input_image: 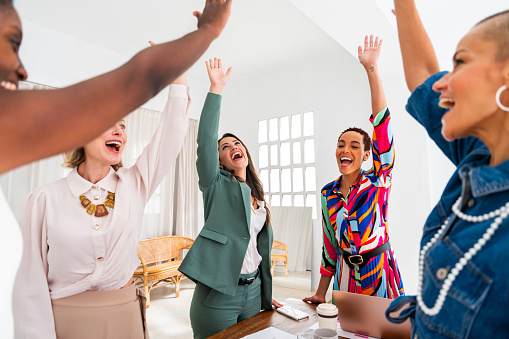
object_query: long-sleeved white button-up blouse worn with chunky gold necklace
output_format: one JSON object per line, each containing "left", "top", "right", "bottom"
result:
{"left": 13, "top": 85, "right": 190, "bottom": 338}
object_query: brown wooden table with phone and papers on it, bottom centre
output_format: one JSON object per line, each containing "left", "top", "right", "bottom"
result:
{"left": 210, "top": 300, "right": 343, "bottom": 339}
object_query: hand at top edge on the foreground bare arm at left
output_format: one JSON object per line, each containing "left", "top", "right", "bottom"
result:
{"left": 193, "top": 0, "right": 233, "bottom": 38}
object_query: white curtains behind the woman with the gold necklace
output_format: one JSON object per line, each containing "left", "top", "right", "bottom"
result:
{"left": 0, "top": 82, "right": 201, "bottom": 242}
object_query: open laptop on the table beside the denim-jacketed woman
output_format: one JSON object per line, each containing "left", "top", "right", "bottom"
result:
{"left": 332, "top": 291, "right": 411, "bottom": 339}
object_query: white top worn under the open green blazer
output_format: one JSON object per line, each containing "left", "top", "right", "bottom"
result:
{"left": 240, "top": 200, "right": 267, "bottom": 274}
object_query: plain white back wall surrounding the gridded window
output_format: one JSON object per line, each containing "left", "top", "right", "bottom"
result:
{"left": 216, "top": 46, "right": 430, "bottom": 292}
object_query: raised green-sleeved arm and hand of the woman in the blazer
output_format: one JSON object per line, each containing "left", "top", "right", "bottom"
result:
{"left": 196, "top": 58, "right": 232, "bottom": 190}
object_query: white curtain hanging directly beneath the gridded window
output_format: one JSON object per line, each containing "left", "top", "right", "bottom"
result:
{"left": 270, "top": 206, "right": 313, "bottom": 272}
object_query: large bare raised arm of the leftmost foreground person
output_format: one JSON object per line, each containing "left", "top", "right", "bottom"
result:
{"left": 0, "top": 0, "right": 232, "bottom": 173}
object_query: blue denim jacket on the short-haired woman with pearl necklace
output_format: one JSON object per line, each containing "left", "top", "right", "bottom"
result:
{"left": 387, "top": 73, "right": 509, "bottom": 339}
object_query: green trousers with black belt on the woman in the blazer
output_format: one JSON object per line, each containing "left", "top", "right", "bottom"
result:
{"left": 190, "top": 271, "right": 262, "bottom": 339}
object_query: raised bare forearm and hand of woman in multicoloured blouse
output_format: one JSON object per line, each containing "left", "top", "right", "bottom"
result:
{"left": 358, "top": 35, "right": 387, "bottom": 118}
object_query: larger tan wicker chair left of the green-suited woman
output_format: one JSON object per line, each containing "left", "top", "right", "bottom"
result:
{"left": 133, "top": 235, "right": 194, "bottom": 308}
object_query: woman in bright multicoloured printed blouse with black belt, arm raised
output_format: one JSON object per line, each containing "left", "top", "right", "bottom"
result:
{"left": 303, "top": 36, "right": 404, "bottom": 303}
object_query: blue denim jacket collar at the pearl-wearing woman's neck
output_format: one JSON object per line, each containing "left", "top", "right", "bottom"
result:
{"left": 458, "top": 146, "right": 509, "bottom": 198}
